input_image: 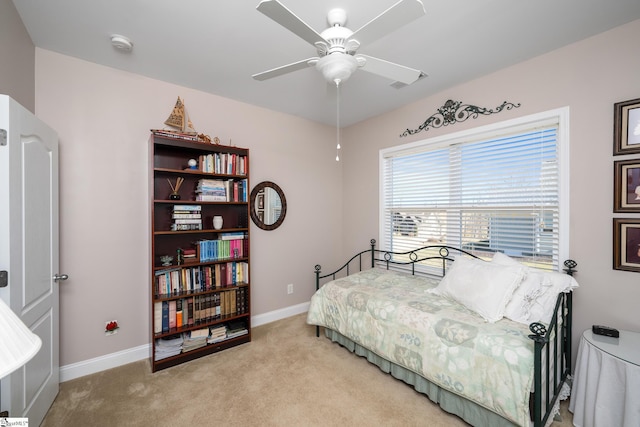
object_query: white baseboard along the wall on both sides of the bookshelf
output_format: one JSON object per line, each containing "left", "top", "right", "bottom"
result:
{"left": 60, "top": 302, "right": 309, "bottom": 383}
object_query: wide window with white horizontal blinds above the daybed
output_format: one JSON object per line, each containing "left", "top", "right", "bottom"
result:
{"left": 380, "top": 108, "right": 569, "bottom": 270}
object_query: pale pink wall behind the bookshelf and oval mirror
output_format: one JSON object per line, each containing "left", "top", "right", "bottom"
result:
{"left": 36, "top": 49, "right": 342, "bottom": 366}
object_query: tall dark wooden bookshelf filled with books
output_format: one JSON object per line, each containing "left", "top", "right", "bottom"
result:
{"left": 149, "top": 131, "right": 251, "bottom": 372}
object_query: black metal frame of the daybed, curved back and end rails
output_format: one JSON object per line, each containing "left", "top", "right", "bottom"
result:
{"left": 315, "top": 239, "right": 577, "bottom": 427}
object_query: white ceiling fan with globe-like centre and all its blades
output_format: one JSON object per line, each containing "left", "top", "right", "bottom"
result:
{"left": 252, "top": 0, "right": 426, "bottom": 86}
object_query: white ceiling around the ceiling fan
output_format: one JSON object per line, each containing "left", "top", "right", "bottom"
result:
{"left": 13, "top": 0, "right": 640, "bottom": 126}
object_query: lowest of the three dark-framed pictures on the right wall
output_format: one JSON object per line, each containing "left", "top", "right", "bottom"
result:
{"left": 613, "top": 218, "right": 640, "bottom": 272}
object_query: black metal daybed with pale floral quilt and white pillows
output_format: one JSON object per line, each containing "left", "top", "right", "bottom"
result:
{"left": 307, "top": 240, "right": 578, "bottom": 427}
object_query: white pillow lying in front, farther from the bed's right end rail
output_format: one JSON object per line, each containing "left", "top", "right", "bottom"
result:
{"left": 427, "top": 257, "right": 524, "bottom": 323}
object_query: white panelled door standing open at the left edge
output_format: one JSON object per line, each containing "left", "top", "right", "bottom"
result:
{"left": 0, "top": 95, "right": 60, "bottom": 426}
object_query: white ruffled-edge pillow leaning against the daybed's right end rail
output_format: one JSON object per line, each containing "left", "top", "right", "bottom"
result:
{"left": 491, "top": 252, "right": 578, "bottom": 325}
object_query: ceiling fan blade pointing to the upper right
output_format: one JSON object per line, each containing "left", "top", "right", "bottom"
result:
{"left": 349, "top": 0, "right": 425, "bottom": 45}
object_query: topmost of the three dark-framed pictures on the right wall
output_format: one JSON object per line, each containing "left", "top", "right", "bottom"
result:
{"left": 613, "top": 98, "right": 640, "bottom": 155}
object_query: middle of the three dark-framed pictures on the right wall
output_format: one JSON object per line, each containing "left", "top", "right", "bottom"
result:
{"left": 613, "top": 159, "right": 640, "bottom": 212}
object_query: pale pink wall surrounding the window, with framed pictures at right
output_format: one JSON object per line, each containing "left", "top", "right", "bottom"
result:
{"left": 342, "top": 21, "right": 640, "bottom": 362}
